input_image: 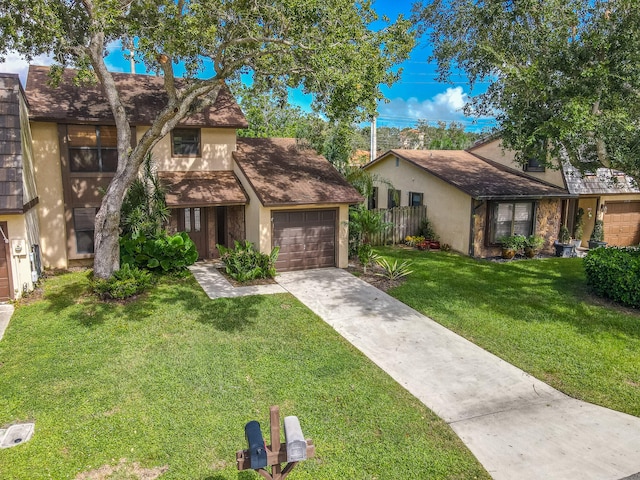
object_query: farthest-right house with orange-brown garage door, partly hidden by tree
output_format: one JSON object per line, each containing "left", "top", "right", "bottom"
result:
{"left": 469, "top": 139, "right": 640, "bottom": 246}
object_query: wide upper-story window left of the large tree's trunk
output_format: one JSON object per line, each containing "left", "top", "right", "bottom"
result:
{"left": 67, "top": 125, "right": 118, "bottom": 172}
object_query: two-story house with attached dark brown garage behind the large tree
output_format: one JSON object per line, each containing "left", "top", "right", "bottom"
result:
{"left": 26, "top": 66, "right": 362, "bottom": 280}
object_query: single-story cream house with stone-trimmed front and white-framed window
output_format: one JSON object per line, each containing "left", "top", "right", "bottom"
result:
{"left": 364, "top": 150, "right": 572, "bottom": 257}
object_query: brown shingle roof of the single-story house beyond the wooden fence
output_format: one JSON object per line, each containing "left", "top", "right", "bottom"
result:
{"left": 365, "top": 150, "right": 571, "bottom": 200}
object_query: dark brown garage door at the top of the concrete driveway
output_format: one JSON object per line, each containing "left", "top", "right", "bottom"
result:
{"left": 271, "top": 210, "right": 336, "bottom": 272}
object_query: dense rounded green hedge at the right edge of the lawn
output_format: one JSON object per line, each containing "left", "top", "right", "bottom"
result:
{"left": 584, "top": 247, "right": 640, "bottom": 308}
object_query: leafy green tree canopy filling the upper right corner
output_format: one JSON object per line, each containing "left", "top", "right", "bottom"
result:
{"left": 415, "top": 0, "right": 640, "bottom": 184}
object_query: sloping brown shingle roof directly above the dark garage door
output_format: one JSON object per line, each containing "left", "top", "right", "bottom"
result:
{"left": 233, "top": 138, "right": 363, "bottom": 206}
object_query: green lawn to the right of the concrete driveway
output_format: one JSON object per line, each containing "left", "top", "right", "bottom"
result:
{"left": 378, "top": 248, "right": 640, "bottom": 416}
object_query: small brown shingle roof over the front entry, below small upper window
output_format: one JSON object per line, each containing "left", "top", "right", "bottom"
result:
{"left": 158, "top": 171, "right": 248, "bottom": 208}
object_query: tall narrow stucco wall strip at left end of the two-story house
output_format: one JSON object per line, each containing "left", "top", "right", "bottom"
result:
{"left": 31, "top": 122, "right": 67, "bottom": 268}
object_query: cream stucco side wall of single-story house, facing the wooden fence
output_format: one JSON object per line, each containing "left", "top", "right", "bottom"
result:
{"left": 367, "top": 155, "right": 471, "bottom": 255}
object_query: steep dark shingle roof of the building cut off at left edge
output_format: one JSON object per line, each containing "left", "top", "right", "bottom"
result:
{"left": 0, "top": 73, "right": 24, "bottom": 212}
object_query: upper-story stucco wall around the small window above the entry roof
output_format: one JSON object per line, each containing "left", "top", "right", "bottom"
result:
{"left": 141, "top": 127, "right": 236, "bottom": 171}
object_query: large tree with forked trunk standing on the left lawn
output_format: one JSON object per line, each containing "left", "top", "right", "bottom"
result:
{"left": 0, "top": 0, "right": 413, "bottom": 278}
